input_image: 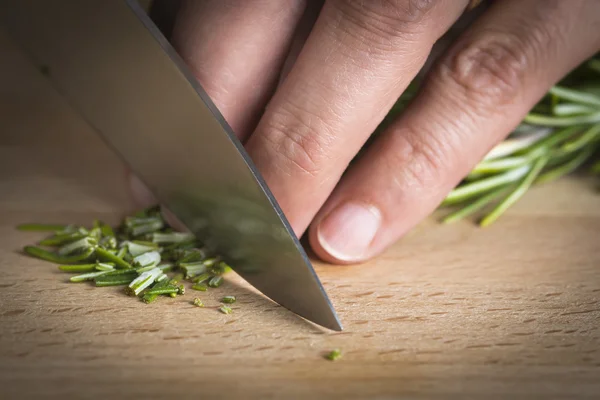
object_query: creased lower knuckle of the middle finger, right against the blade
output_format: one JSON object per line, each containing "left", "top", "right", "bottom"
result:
{"left": 262, "top": 103, "right": 332, "bottom": 177}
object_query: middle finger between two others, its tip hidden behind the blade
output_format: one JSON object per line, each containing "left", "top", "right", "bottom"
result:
{"left": 246, "top": 0, "right": 467, "bottom": 235}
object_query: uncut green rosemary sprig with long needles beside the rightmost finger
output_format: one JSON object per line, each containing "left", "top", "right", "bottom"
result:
{"left": 426, "top": 59, "right": 600, "bottom": 226}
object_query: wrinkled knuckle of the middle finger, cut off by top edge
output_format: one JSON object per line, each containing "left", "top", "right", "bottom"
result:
{"left": 332, "top": 0, "right": 439, "bottom": 43}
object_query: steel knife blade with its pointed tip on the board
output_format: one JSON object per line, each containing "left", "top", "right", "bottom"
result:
{"left": 0, "top": 0, "right": 342, "bottom": 331}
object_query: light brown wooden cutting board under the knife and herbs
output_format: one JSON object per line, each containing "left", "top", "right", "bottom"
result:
{"left": 0, "top": 28, "right": 600, "bottom": 399}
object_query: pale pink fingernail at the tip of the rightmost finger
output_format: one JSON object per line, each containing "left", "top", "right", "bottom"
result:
{"left": 317, "top": 203, "right": 381, "bottom": 262}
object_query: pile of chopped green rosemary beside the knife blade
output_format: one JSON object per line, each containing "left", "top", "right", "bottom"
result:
{"left": 18, "top": 206, "right": 235, "bottom": 305}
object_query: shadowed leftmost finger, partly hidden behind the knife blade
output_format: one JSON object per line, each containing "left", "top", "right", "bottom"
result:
{"left": 172, "top": 0, "right": 305, "bottom": 140}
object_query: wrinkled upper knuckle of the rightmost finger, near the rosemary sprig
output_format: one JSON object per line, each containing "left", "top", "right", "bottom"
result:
{"left": 437, "top": 33, "right": 530, "bottom": 107}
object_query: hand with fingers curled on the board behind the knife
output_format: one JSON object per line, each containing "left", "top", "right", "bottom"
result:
{"left": 130, "top": 0, "right": 600, "bottom": 263}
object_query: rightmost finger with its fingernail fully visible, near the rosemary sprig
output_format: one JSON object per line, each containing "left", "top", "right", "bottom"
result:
{"left": 309, "top": 0, "right": 600, "bottom": 263}
